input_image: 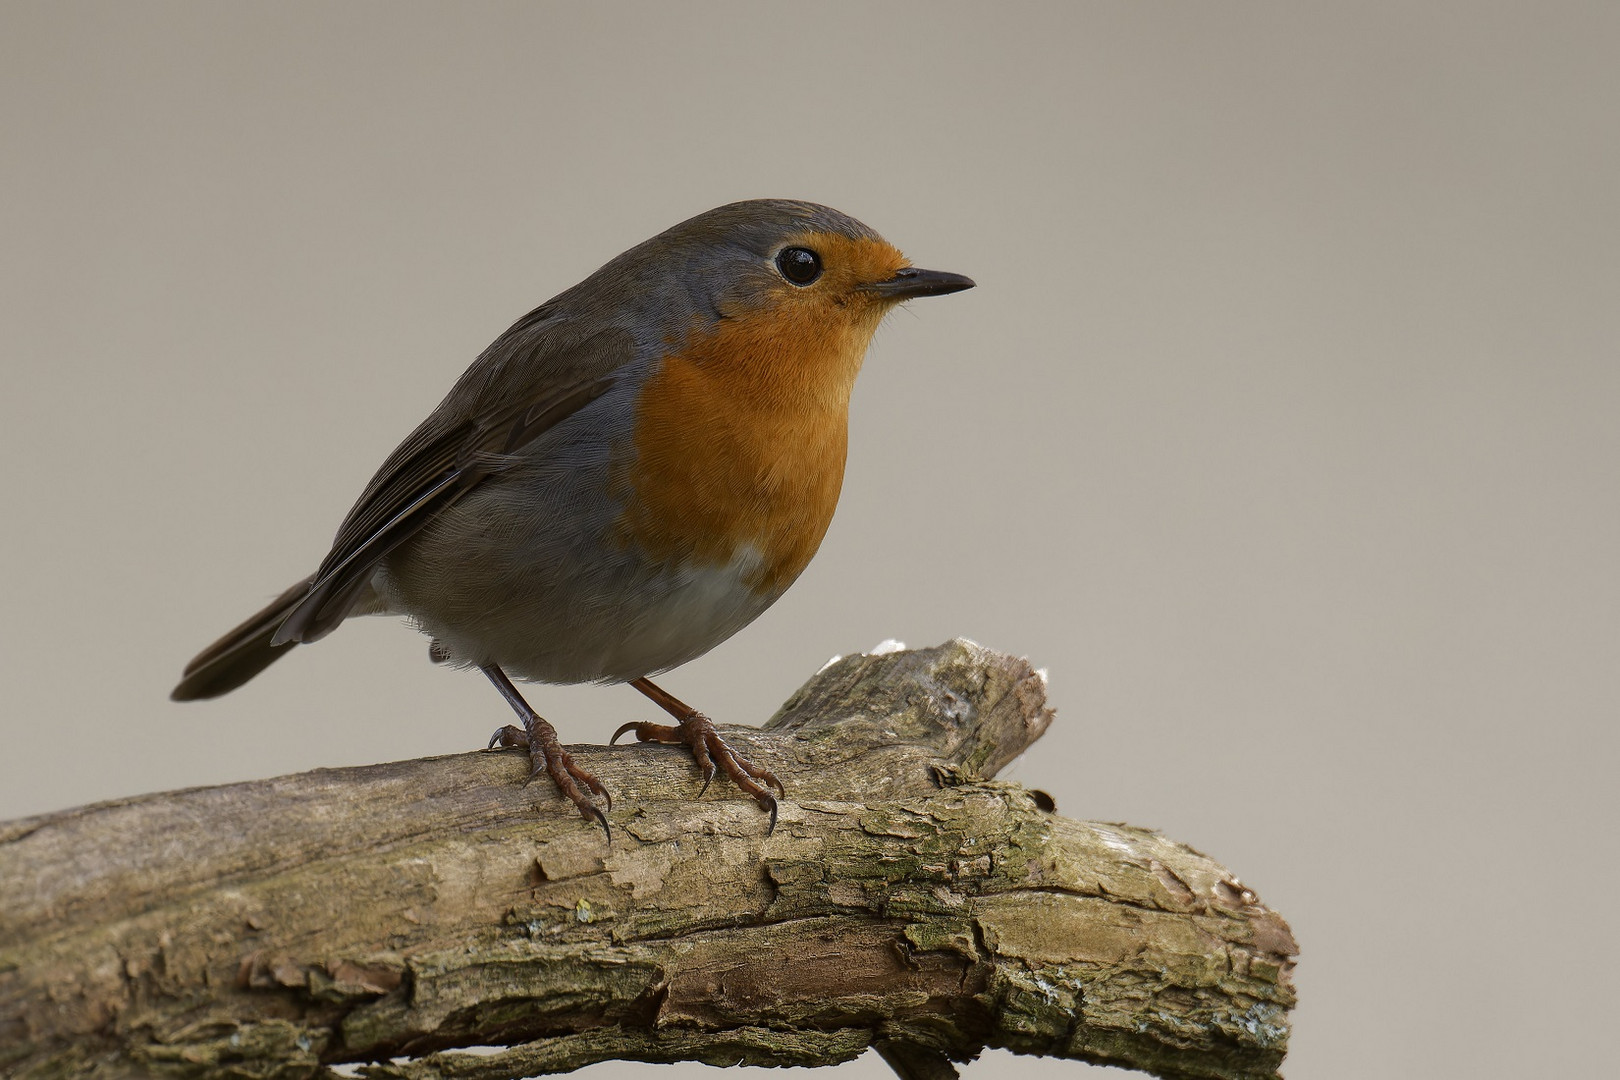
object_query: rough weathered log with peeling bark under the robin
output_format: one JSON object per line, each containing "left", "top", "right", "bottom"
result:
{"left": 0, "top": 641, "right": 1296, "bottom": 1080}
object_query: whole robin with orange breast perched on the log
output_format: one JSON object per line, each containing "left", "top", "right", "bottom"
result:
{"left": 172, "top": 199, "right": 974, "bottom": 840}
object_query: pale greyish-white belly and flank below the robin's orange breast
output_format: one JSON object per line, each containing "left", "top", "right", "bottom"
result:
{"left": 377, "top": 453, "right": 786, "bottom": 683}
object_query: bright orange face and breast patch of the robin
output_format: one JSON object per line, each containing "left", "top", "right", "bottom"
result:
{"left": 619, "top": 233, "right": 907, "bottom": 594}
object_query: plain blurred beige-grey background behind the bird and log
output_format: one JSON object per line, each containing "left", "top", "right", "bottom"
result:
{"left": 0, "top": 0, "right": 1620, "bottom": 1078}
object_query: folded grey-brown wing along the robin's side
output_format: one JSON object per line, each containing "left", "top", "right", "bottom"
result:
{"left": 271, "top": 317, "right": 632, "bottom": 646}
